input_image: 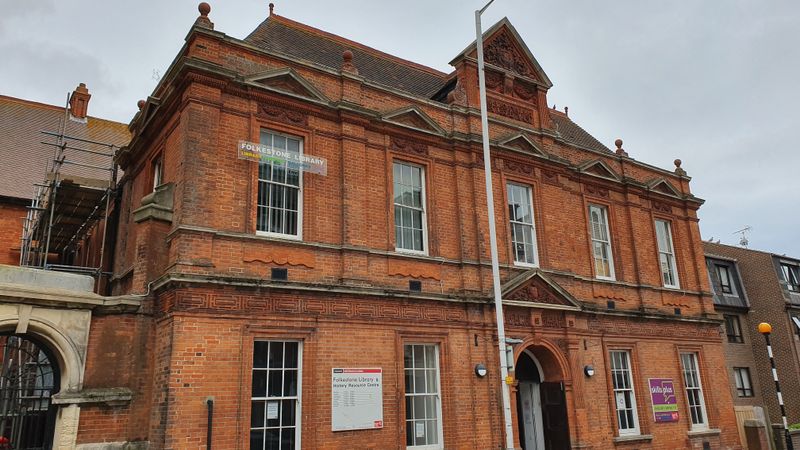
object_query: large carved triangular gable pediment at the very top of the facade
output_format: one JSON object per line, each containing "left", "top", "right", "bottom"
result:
{"left": 450, "top": 17, "right": 553, "bottom": 89}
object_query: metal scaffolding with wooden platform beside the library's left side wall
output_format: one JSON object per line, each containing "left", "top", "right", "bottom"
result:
{"left": 20, "top": 95, "right": 120, "bottom": 285}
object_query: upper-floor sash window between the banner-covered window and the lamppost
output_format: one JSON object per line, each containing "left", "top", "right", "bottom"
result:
{"left": 393, "top": 162, "right": 427, "bottom": 253}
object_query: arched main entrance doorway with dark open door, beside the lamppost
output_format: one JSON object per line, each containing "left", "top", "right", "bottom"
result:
{"left": 515, "top": 350, "right": 570, "bottom": 450}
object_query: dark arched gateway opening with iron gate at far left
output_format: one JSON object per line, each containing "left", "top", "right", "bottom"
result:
{"left": 0, "top": 334, "right": 60, "bottom": 450}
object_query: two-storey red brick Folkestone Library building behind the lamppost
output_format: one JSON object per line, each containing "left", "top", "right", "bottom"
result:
{"left": 0, "top": 5, "right": 740, "bottom": 449}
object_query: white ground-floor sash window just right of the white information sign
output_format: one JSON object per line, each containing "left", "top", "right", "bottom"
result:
{"left": 404, "top": 344, "right": 443, "bottom": 449}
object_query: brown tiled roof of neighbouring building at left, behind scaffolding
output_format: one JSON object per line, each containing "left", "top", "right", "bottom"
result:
{"left": 0, "top": 95, "right": 130, "bottom": 199}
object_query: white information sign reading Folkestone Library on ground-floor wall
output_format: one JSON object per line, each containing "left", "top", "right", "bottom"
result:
{"left": 331, "top": 368, "right": 383, "bottom": 431}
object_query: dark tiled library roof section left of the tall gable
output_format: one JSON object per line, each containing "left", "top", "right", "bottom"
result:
{"left": 244, "top": 14, "right": 448, "bottom": 98}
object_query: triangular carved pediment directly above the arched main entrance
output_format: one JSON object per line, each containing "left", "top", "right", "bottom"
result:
{"left": 503, "top": 269, "right": 581, "bottom": 309}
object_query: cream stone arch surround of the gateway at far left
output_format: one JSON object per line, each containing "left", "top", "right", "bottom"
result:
{"left": 0, "top": 265, "right": 141, "bottom": 449}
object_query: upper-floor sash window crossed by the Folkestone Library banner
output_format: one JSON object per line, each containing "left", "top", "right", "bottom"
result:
{"left": 256, "top": 130, "right": 303, "bottom": 238}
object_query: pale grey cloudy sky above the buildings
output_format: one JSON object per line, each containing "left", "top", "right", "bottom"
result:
{"left": 0, "top": 0, "right": 800, "bottom": 257}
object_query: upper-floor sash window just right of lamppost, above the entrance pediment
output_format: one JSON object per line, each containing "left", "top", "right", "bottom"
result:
{"left": 506, "top": 183, "right": 537, "bottom": 266}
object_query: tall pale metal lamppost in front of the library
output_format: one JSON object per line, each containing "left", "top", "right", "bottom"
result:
{"left": 475, "top": 0, "right": 514, "bottom": 450}
